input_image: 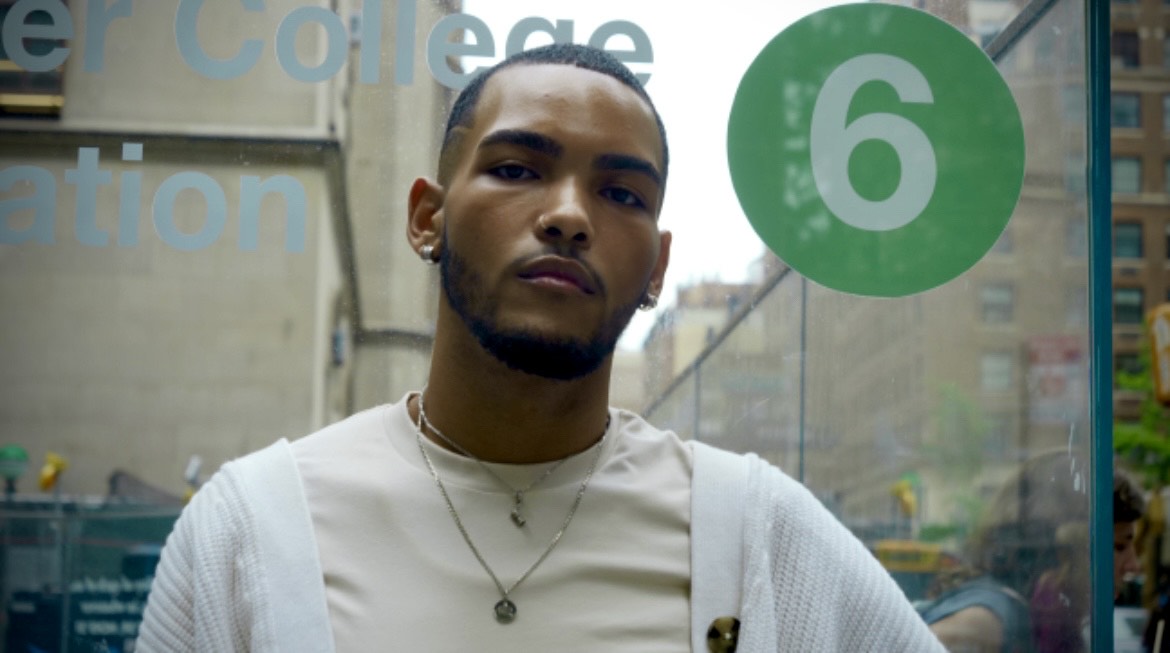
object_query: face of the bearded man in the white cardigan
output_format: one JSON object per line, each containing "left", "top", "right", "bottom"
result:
{"left": 440, "top": 64, "right": 669, "bottom": 379}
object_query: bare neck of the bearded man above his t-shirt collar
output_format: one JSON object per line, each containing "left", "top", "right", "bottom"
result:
{"left": 408, "top": 318, "right": 612, "bottom": 465}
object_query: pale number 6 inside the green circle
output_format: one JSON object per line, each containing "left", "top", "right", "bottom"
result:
{"left": 808, "top": 54, "right": 938, "bottom": 232}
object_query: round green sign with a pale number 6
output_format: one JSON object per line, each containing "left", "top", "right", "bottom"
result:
{"left": 728, "top": 4, "right": 1024, "bottom": 297}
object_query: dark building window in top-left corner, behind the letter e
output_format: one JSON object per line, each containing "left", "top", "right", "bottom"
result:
{"left": 0, "top": 0, "right": 66, "bottom": 118}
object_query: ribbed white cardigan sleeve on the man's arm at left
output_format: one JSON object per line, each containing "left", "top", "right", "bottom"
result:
{"left": 136, "top": 463, "right": 273, "bottom": 653}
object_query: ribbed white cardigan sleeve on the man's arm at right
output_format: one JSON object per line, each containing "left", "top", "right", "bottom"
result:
{"left": 739, "top": 456, "right": 944, "bottom": 653}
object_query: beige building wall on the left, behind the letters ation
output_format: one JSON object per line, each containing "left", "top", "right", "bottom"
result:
{"left": 0, "top": 0, "right": 452, "bottom": 494}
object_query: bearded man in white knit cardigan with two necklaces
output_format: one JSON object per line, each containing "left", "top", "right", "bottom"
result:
{"left": 139, "top": 46, "right": 941, "bottom": 652}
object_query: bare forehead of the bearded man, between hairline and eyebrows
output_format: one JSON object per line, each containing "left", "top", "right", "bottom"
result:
{"left": 472, "top": 64, "right": 662, "bottom": 167}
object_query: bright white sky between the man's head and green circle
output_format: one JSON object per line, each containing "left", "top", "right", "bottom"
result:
{"left": 462, "top": 0, "right": 844, "bottom": 350}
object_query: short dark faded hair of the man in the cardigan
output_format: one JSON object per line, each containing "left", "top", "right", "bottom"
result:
{"left": 439, "top": 43, "right": 670, "bottom": 184}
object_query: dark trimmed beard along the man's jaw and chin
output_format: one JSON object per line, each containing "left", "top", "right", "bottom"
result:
{"left": 439, "top": 241, "right": 641, "bottom": 380}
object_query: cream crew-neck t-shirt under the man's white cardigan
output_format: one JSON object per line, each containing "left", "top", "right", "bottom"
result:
{"left": 293, "top": 399, "right": 691, "bottom": 653}
